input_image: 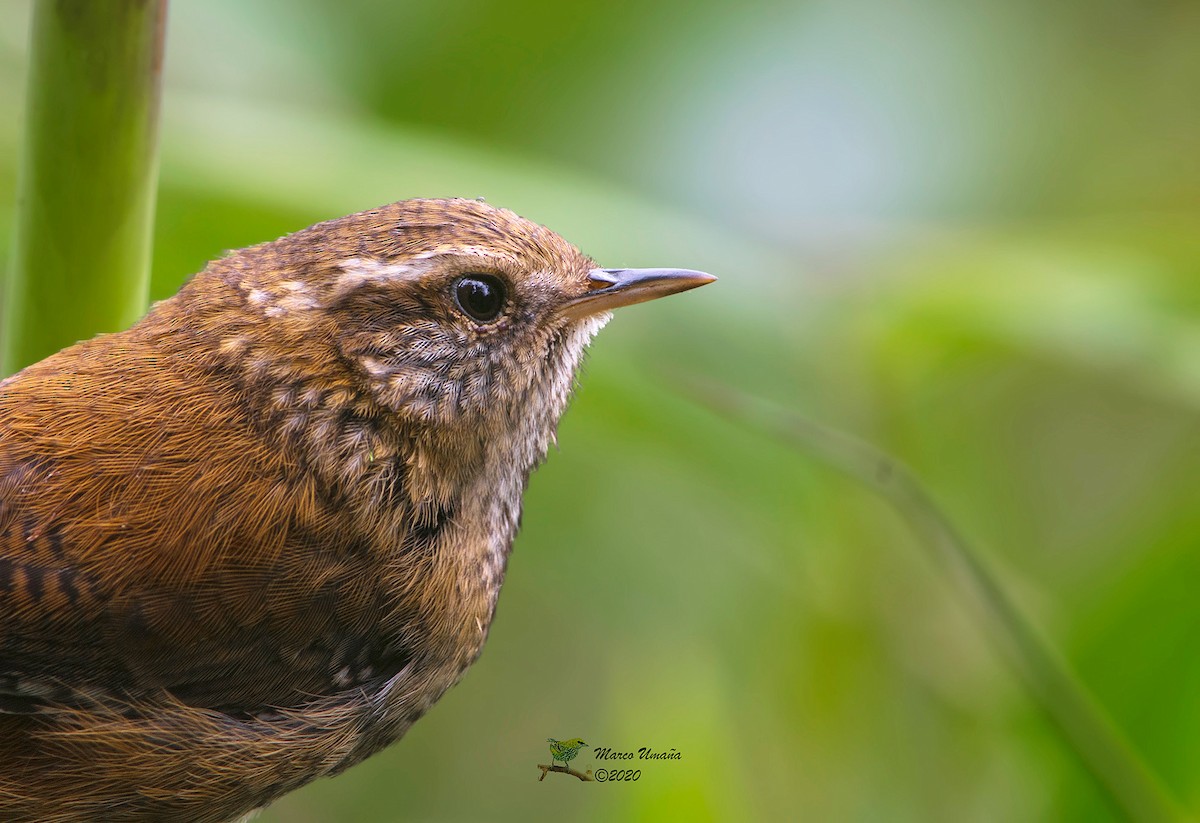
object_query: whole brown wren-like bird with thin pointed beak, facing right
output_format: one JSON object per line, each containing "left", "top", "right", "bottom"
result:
{"left": 0, "top": 200, "right": 714, "bottom": 823}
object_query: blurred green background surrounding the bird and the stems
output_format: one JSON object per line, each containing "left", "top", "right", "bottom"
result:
{"left": 0, "top": 0, "right": 1200, "bottom": 823}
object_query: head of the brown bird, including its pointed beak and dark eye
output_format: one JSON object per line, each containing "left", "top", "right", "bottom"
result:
{"left": 206, "top": 199, "right": 715, "bottom": 428}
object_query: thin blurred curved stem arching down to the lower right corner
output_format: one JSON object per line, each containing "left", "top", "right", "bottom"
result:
{"left": 685, "top": 383, "right": 1189, "bottom": 823}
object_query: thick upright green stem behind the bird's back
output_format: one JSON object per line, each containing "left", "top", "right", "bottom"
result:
{"left": 0, "top": 0, "right": 167, "bottom": 374}
